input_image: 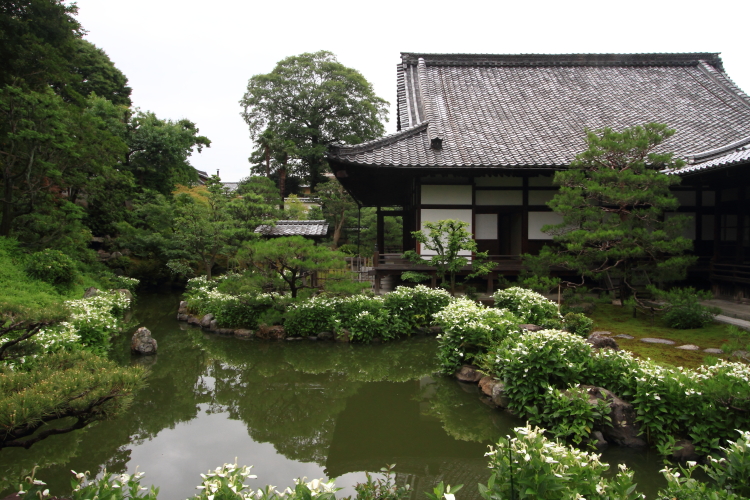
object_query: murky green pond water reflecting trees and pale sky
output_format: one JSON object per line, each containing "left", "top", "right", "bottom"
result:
{"left": 0, "top": 294, "right": 664, "bottom": 500}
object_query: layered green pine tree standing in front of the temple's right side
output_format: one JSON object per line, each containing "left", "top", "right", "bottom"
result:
{"left": 527, "top": 123, "right": 695, "bottom": 299}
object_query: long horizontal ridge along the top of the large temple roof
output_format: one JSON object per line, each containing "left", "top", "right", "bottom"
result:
{"left": 401, "top": 52, "right": 724, "bottom": 71}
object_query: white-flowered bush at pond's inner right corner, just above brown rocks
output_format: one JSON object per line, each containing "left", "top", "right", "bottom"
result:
{"left": 435, "top": 298, "right": 520, "bottom": 373}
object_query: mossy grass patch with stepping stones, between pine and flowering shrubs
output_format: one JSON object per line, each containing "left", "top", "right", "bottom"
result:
{"left": 589, "top": 304, "right": 729, "bottom": 368}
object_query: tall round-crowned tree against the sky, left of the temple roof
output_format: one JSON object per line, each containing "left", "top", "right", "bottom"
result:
{"left": 240, "top": 51, "right": 388, "bottom": 187}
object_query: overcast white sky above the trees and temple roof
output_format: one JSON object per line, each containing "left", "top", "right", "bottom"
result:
{"left": 77, "top": 0, "right": 750, "bottom": 181}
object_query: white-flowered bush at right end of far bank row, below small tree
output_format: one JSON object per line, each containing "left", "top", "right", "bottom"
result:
{"left": 384, "top": 285, "right": 451, "bottom": 334}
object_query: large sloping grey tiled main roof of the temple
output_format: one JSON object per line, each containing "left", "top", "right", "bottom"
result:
{"left": 329, "top": 53, "right": 750, "bottom": 168}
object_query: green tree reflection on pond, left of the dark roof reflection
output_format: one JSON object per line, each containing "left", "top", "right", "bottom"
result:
{"left": 194, "top": 335, "right": 435, "bottom": 465}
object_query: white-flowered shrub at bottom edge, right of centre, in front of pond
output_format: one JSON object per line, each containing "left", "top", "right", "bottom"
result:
{"left": 479, "top": 424, "right": 645, "bottom": 500}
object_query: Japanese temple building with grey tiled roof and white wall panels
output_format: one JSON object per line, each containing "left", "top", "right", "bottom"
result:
{"left": 328, "top": 53, "right": 750, "bottom": 297}
